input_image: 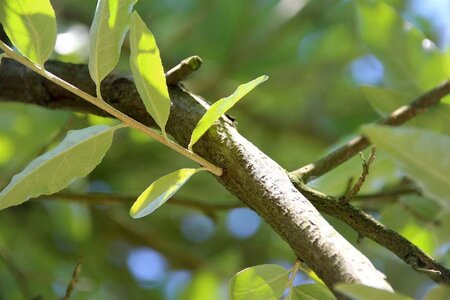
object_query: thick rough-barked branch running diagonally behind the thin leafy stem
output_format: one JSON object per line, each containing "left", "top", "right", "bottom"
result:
{"left": 0, "top": 59, "right": 391, "bottom": 290}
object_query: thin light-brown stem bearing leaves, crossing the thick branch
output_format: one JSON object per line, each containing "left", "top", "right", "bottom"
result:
{"left": 0, "top": 41, "right": 222, "bottom": 177}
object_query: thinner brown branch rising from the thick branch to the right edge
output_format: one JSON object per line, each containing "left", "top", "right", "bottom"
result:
{"left": 290, "top": 81, "right": 450, "bottom": 182}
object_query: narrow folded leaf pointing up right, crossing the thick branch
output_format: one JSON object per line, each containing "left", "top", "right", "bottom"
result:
{"left": 188, "top": 75, "right": 269, "bottom": 150}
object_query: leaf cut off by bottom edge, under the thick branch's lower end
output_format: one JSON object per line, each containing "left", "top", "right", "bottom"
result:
{"left": 335, "top": 283, "right": 412, "bottom": 300}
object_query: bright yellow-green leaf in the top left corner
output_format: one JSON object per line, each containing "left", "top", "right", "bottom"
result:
{"left": 0, "top": 0, "right": 56, "bottom": 66}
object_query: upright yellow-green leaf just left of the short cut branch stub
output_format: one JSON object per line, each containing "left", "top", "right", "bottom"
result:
{"left": 130, "top": 12, "right": 170, "bottom": 134}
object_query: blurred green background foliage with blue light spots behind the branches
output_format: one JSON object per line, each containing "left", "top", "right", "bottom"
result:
{"left": 0, "top": 0, "right": 450, "bottom": 300}
